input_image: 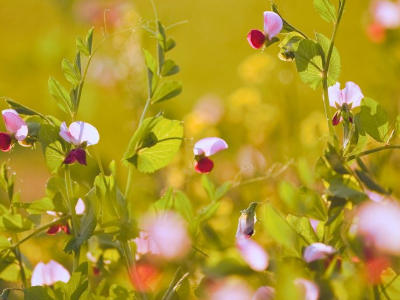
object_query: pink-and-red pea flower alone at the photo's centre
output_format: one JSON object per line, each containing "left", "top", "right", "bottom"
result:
{"left": 193, "top": 137, "right": 228, "bottom": 174}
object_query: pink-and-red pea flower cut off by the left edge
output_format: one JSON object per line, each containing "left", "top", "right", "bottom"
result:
{"left": 0, "top": 109, "right": 28, "bottom": 152}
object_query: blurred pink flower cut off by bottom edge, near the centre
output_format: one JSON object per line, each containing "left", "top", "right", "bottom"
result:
{"left": 208, "top": 280, "right": 253, "bottom": 300}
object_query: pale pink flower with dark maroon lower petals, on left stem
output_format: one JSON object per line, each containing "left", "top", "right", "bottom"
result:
{"left": 60, "top": 121, "right": 100, "bottom": 166}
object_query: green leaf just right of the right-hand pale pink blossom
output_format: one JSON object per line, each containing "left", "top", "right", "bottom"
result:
{"left": 360, "top": 98, "right": 389, "bottom": 143}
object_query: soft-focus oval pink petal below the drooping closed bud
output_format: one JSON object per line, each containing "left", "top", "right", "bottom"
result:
{"left": 236, "top": 239, "right": 269, "bottom": 272}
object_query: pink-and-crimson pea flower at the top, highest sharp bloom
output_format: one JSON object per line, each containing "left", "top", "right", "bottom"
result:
{"left": 247, "top": 11, "right": 283, "bottom": 49}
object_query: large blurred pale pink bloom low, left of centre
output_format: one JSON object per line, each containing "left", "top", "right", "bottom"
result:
{"left": 141, "top": 211, "right": 191, "bottom": 260}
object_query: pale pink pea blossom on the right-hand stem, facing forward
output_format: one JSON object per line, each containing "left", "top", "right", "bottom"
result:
{"left": 328, "top": 81, "right": 364, "bottom": 126}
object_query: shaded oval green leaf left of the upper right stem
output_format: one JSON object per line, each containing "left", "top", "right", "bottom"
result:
{"left": 295, "top": 40, "right": 323, "bottom": 90}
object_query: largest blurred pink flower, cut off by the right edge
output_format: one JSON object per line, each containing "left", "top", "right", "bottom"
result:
{"left": 356, "top": 201, "right": 400, "bottom": 255}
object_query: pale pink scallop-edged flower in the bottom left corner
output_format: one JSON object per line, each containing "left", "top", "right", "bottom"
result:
{"left": 31, "top": 260, "right": 71, "bottom": 286}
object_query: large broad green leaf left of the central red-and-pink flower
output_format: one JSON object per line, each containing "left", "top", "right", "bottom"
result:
{"left": 123, "top": 117, "right": 183, "bottom": 173}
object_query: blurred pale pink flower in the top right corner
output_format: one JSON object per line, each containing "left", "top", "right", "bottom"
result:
{"left": 371, "top": 0, "right": 400, "bottom": 29}
